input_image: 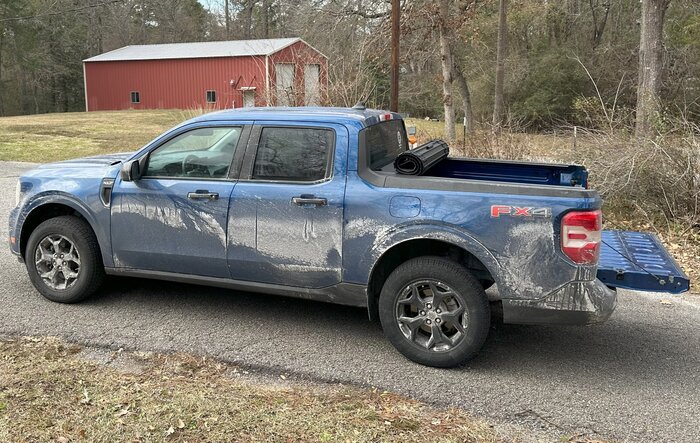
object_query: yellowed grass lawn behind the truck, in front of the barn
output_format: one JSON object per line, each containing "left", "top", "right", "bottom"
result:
{"left": 0, "top": 110, "right": 571, "bottom": 163}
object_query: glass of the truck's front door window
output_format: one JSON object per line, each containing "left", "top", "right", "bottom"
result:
{"left": 143, "top": 127, "right": 242, "bottom": 178}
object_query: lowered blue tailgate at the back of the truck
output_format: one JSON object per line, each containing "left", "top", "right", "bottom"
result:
{"left": 597, "top": 231, "right": 690, "bottom": 294}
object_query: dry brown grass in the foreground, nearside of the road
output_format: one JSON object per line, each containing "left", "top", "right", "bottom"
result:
{"left": 0, "top": 337, "right": 504, "bottom": 442}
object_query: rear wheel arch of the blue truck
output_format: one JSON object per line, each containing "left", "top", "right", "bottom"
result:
{"left": 367, "top": 226, "right": 500, "bottom": 319}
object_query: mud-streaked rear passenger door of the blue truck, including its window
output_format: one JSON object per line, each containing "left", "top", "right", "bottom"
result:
{"left": 228, "top": 122, "right": 348, "bottom": 288}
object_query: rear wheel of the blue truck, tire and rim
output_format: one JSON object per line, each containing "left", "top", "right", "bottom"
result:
{"left": 379, "top": 257, "right": 491, "bottom": 368}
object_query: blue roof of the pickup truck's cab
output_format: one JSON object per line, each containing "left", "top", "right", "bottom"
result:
{"left": 190, "top": 107, "right": 401, "bottom": 127}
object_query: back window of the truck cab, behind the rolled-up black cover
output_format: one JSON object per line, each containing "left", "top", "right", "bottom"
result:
{"left": 364, "top": 120, "right": 408, "bottom": 171}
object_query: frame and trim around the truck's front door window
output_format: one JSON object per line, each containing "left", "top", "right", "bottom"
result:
{"left": 138, "top": 123, "right": 252, "bottom": 182}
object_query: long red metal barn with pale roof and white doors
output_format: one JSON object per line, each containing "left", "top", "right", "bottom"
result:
{"left": 83, "top": 38, "right": 328, "bottom": 111}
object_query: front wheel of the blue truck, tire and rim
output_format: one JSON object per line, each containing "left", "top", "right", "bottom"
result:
{"left": 24, "top": 216, "right": 105, "bottom": 303}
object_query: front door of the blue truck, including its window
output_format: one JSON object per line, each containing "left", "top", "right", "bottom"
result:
{"left": 112, "top": 125, "right": 245, "bottom": 277}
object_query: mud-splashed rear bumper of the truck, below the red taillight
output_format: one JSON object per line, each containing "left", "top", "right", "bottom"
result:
{"left": 503, "top": 279, "right": 617, "bottom": 325}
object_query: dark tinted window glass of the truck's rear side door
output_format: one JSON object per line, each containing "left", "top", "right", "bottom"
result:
{"left": 253, "top": 128, "right": 334, "bottom": 182}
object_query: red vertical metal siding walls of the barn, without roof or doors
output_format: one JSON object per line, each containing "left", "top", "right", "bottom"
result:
{"left": 84, "top": 42, "right": 328, "bottom": 111}
